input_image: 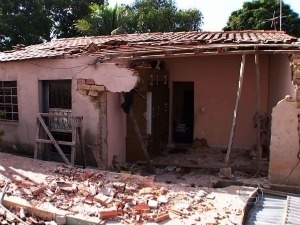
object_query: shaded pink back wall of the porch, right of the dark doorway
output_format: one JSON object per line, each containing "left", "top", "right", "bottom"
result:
{"left": 166, "top": 55, "right": 269, "bottom": 147}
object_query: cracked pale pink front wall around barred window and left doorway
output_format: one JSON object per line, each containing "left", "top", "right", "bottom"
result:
{"left": 0, "top": 56, "right": 137, "bottom": 165}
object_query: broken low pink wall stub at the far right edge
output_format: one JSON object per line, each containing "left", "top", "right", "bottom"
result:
{"left": 269, "top": 100, "right": 300, "bottom": 186}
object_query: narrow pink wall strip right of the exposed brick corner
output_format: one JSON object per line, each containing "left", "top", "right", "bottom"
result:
{"left": 107, "top": 93, "right": 126, "bottom": 165}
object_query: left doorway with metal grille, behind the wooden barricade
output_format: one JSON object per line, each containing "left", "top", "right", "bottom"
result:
{"left": 42, "top": 80, "right": 72, "bottom": 162}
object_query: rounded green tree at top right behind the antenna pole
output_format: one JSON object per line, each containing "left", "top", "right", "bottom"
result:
{"left": 223, "top": 0, "right": 300, "bottom": 37}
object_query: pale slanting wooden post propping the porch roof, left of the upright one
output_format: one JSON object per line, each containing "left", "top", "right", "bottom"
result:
{"left": 225, "top": 54, "right": 246, "bottom": 166}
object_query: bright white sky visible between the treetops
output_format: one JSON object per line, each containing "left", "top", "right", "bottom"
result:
{"left": 108, "top": 0, "right": 300, "bottom": 31}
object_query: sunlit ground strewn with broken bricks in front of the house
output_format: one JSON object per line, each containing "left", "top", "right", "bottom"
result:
{"left": 0, "top": 150, "right": 268, "bottom": 225}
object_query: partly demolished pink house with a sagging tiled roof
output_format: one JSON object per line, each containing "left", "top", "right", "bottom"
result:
{"left": 0, "top": 30, "right": 300, "bottom": 185}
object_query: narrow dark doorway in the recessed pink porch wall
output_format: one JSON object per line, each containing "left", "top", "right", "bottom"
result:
{"left": 173, "top": 82, "right": 194, "bottom": 143}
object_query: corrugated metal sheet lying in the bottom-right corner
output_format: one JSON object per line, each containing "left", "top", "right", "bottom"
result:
{"left": 245, "top": 194, "right": 300, "bottom": 225}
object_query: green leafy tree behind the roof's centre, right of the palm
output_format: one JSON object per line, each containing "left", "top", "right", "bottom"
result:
{"left": 127, "top": 0, "right": 203, "bottom": 33}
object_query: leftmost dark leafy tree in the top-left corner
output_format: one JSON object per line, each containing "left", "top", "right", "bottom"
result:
{"left": 0, "top": 0, "right": 52, "bottom": 50}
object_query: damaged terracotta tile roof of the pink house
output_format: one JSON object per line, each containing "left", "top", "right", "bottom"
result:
{"left": 0, "top": 30, "right": 299, "bottom": 62}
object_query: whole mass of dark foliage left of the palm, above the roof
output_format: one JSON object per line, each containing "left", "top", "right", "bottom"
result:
{"left": 0, "top": 0, "right": 104, "bottom": 51}
